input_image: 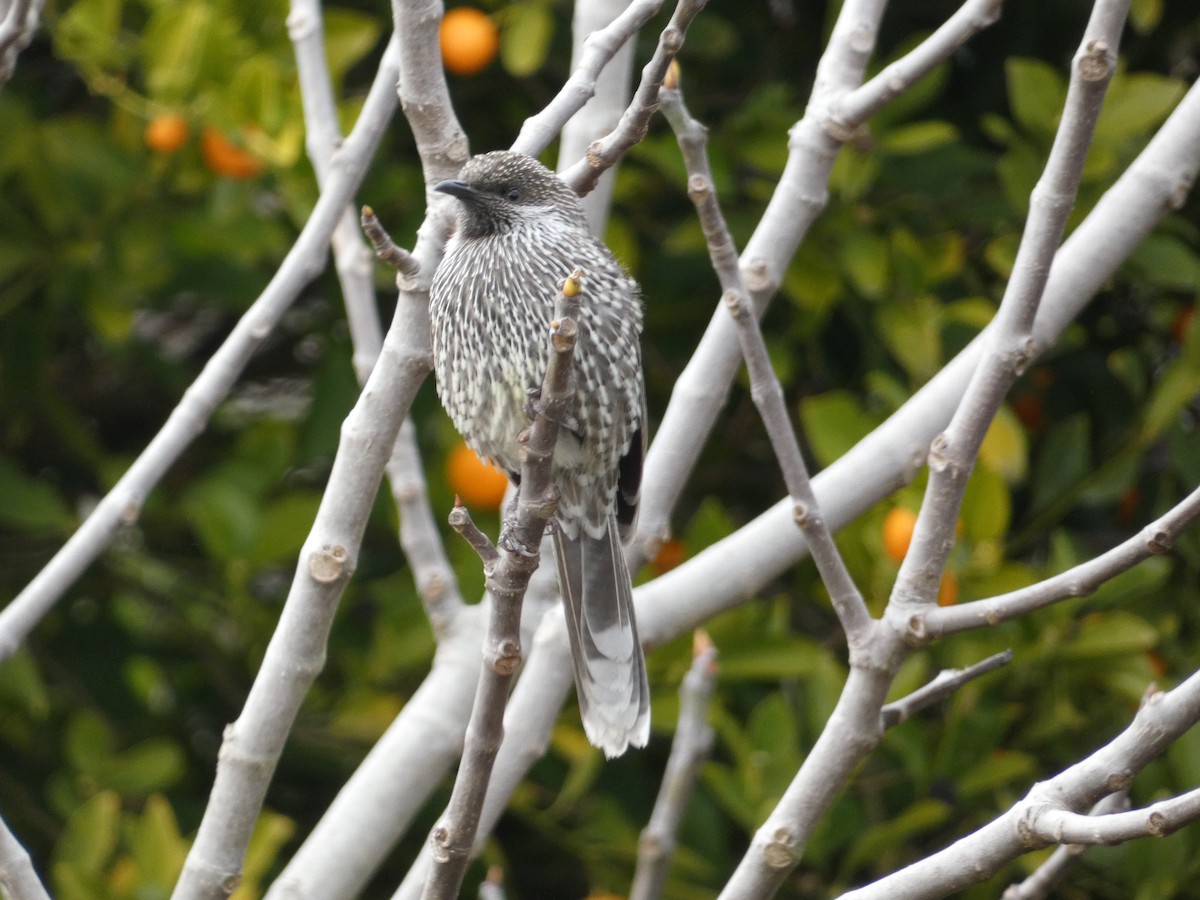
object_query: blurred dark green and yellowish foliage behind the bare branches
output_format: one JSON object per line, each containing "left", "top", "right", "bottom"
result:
{"left": 0, "top": 0, "right": 1200, "bottom": 900}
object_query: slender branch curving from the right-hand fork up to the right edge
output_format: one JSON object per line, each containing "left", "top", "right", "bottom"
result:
{"left": 908, "top": 488, "right": 1200, "bottom": 641}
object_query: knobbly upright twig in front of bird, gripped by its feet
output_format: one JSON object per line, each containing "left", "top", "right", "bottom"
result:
{"left": 422, "top": 270, "right": 583, "bottom": 900}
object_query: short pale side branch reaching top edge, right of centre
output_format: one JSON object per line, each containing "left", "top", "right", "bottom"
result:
{"left": 829, "top": 0, "right": 1003, "bottom": 128}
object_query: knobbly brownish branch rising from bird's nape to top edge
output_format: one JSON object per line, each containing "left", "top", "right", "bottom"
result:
{"left": 563, "top": 0, "right": 707, "bottom": 194}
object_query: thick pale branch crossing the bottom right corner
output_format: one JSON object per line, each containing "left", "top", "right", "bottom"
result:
{"left": 842, "top": 672, "right": 1200, "bottom": 900}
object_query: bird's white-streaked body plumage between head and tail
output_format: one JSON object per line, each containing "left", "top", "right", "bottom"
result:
{"left": 430, "top": 229, "right": 642, "bottom": 534}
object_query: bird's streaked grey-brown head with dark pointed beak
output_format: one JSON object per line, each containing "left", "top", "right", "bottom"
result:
{"left": 433, "top": 150, "right": 587, "bottom": 238}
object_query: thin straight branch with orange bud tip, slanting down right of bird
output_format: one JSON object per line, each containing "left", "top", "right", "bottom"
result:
{"left": 661, "top": 78, "right": 871, "bottom": 649}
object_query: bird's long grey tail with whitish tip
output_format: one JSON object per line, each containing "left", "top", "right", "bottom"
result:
{"left": 553, "top": 516, "right": 650, "bottom": 758}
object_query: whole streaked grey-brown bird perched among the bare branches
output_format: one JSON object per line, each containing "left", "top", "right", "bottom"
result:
{"left": 430, "top": 151, "right": 650, "bottom": 756}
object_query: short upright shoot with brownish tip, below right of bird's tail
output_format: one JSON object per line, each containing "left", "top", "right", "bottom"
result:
{"left": 629, "top": 632, "right": 718, "bottom": 900}
